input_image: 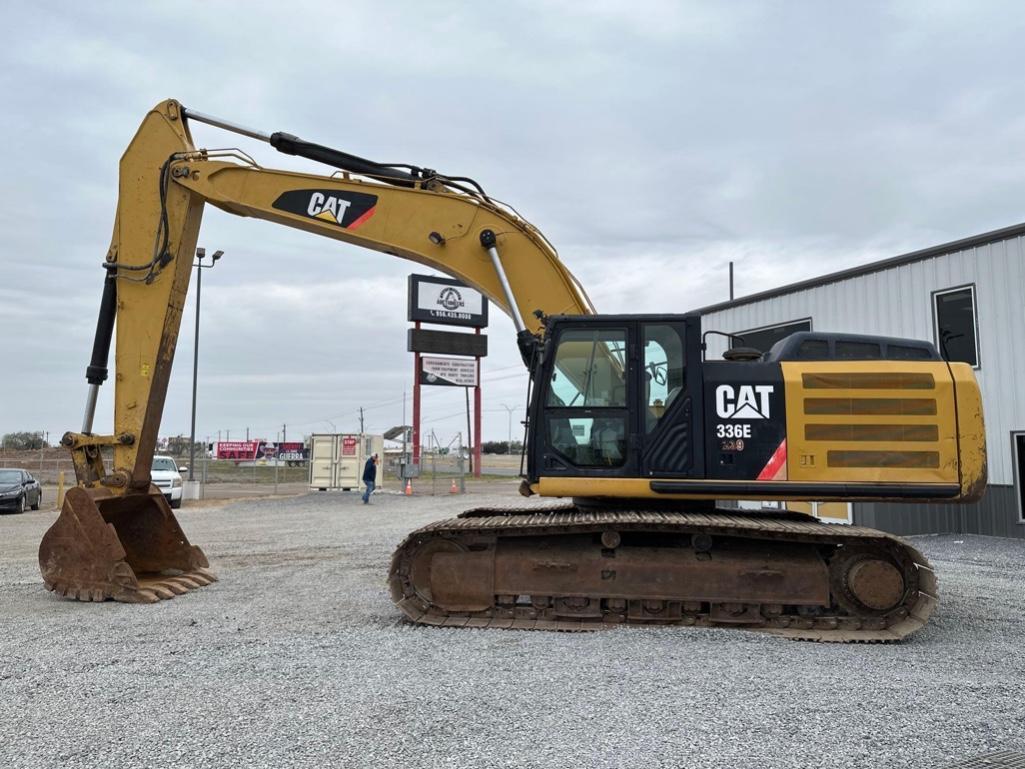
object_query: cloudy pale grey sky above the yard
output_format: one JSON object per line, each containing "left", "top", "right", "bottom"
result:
{"left": 0, "top": 0, "right": 1025, "bottom": 445}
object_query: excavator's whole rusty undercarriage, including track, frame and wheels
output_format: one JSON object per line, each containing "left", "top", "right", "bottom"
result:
{"left": 388, "top": 504, "right": 937, "bottom": 642}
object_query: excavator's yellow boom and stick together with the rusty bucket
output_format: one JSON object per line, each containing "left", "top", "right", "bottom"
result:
{"left": 46, "top": 100, "right": 593, "bottom": 601}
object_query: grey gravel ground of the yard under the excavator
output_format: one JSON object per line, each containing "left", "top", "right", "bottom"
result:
{"left": 0, "top": 493, "right": 1025, "bottom": 769}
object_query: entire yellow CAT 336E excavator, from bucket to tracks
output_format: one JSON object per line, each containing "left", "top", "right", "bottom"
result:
{"left": 39, "top": 100, "right": 986, "bottom": 641}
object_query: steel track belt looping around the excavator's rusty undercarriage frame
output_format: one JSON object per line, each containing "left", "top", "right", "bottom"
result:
{"left": 390, "top": 505, "right": 938, "bottom": 643}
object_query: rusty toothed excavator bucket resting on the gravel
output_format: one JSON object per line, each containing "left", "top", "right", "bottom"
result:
{"left": 39, "top": 487, "right": 216, "bottom": 603}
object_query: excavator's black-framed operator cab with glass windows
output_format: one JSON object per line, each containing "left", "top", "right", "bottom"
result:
{"left": 528, "top": 315, "right": 703, "bottom": 479}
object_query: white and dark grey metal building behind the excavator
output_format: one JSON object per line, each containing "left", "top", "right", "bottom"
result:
{"left": 698, "top": 224, "right": 1025, "bottom": 537}
